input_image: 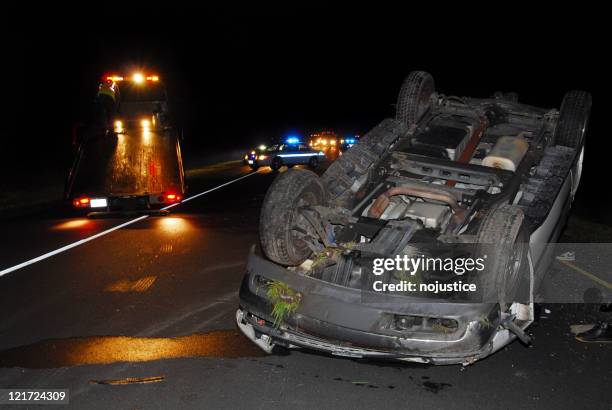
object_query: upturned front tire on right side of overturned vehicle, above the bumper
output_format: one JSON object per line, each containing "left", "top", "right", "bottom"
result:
{"left": 476, "top": 204, "right": 529, "bottom": 310}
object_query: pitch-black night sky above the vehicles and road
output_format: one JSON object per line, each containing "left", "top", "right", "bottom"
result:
{"left": 2, "top": 3, "right": 609, "bottom": 218}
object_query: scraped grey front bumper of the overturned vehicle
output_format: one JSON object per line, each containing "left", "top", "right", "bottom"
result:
{"left": 236, "top": 248, "right": 516, "bottom": 364}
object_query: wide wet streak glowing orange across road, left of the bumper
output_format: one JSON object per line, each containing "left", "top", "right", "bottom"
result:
{"left": 0, "top": 330, "right": 264, "bottom": 369}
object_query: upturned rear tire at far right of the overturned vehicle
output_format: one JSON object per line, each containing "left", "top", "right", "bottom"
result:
{"left": 555, "top": 90, "right": 592, "bottom": 150}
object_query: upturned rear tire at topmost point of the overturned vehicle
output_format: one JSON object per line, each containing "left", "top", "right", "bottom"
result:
{"left": 395, "top": 71, "right": 436, "bottom": 127}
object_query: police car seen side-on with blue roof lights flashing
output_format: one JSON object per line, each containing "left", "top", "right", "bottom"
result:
{"left": 247, "top": 137, "right": 326, "bottom": 171}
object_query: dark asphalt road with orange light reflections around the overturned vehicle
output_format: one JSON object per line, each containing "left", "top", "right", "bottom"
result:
{"left": 0, "top": 159, "right": 612, "bottom": 409}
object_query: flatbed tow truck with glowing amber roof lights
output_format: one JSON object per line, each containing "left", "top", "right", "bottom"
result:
{"left": 65, "top": 72, "right": 186, "bottom": 216}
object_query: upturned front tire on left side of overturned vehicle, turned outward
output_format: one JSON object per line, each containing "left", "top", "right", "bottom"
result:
{"left": 259, "top": 169, "right": 328, "bottom": 266}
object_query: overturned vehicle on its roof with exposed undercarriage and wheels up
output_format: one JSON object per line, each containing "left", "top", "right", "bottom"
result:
{"left": 236, "top": 71, "right": 591, "bottom": 364}
